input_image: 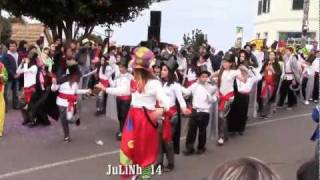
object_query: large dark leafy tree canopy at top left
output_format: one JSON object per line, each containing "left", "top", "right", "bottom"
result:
{"left": 0, "top": 0, "right": 153, "bottom": 40}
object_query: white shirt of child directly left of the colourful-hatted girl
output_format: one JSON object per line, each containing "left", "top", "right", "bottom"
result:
{"left": 106, "top": 73, "right": 133, "bottom": 96}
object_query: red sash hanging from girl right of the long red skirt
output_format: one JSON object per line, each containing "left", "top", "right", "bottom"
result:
{"left": 162, "top": 106, "right": 177, "bottom": 142}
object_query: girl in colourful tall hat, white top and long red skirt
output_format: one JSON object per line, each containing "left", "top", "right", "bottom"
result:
{"left": 96, "top": 47, "right": 170, "bottom": 179}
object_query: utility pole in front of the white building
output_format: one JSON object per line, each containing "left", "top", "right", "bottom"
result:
{"left": 301, "top": 0, "right": 310, "bottom": 48}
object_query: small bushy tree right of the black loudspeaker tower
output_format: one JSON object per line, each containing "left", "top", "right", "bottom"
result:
{"left": 183, "top": 29, "right": 207, "bottom": 50}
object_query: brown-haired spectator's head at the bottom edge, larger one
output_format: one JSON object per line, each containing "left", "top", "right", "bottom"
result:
{"left": 208, "top": 157, "right": 280, "bottom": 180}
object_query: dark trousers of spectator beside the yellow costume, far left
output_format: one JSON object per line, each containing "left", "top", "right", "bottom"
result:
{"left": 4, "top": 79, "right": 20, "bottom": 109}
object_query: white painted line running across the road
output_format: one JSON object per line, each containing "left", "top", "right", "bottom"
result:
{"left": 0, "top": 113, "right": 310, "bottom": 179}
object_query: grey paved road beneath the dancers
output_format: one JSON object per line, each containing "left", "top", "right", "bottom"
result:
{"left": 0, "top": 97, "right": 315, "bottom": 180}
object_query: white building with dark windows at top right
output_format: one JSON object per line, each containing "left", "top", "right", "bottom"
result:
{"left": 254, "top": 0, "right": 320, "bottom": 45}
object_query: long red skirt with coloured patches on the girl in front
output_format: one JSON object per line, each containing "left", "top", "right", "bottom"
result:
{"left": 120, "top": 107, "right": 159, "bottom": 168}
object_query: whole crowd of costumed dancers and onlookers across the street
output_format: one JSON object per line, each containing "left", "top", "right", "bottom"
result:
{"left": 0, "top": 39, "right": 320, "bottom": 179}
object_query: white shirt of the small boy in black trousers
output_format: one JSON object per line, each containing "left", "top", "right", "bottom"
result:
{"left": 184, "top": 82, "right": 217, "bottom": 113}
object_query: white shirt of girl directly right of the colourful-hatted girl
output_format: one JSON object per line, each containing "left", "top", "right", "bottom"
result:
{"left": 160, "top": 82, "right": 187, "bottom": 109}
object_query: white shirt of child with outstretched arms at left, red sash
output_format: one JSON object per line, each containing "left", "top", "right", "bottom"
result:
{"left": 51, "top": 81, "right": 88, "bottom": 107}
